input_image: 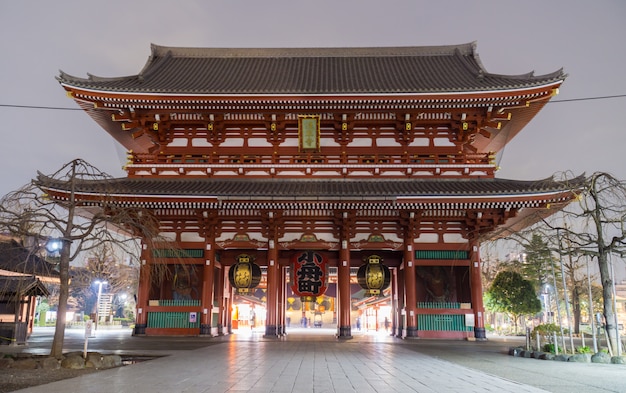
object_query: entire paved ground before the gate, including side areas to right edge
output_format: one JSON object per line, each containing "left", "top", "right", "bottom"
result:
{"left": 0, "top": 329, "right": 626, "bottom": 393}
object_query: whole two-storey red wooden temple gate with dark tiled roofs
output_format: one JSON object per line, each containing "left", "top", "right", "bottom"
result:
{"left": 46, "top": 43, "right": 572, "bottom": 339}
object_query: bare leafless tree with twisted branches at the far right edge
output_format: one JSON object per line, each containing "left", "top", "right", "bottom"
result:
{"left": 486, "top": 172, "right": 626, "bottom": 353}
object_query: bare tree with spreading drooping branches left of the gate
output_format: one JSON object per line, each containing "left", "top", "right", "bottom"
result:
{"left": 0, "top": 159, "right": 166, "bottom": 358}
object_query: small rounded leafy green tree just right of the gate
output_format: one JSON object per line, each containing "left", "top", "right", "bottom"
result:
{"left": 485, "top": 270, "right": 541, "bottom": 332}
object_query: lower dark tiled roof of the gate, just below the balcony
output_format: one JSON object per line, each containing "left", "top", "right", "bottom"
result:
{"left": 38, "top": 174, "right": 584, "bottom": 200}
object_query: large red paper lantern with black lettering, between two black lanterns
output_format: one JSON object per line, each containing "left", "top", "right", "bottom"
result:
{"left": 290, "top": 251, "right": 328, "bottom": 302}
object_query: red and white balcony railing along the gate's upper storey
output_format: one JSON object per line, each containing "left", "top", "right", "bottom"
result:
{"left": 125, "top": 153, "right": 497, "bottom": 178}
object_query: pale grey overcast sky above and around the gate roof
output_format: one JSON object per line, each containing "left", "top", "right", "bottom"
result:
{"left": 0, "top": 0, "right": 626, "bottom": 199}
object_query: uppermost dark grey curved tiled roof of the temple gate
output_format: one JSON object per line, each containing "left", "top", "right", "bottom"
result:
{"left": 57, "top": 43, "right": 565, "bottom": 95}
